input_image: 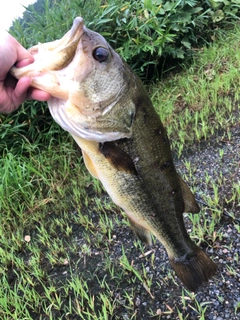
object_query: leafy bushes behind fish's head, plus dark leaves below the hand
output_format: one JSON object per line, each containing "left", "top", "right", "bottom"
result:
{"left": 0, "top": 0, "right": 240, "bottom": 152}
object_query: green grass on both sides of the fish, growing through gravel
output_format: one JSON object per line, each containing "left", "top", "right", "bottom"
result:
{"left": 0, "top": 12, "right": 240, "bottom": 320}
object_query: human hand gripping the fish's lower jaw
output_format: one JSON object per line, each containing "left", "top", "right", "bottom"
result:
{"left": 0, "top": 31, "right": 51, "bottom": 113}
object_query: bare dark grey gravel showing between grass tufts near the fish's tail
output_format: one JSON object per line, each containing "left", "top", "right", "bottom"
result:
{"left": 9, "top": 120, "right": 240, "bottom": 320}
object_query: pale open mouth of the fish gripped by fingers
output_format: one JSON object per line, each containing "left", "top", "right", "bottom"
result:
{"left": 10, "top": 17, "right": 85, "bottom": 100}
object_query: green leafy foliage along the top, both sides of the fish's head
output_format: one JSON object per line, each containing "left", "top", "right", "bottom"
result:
{"left": 14, "top": 0, "right": 240, "bottom": 78}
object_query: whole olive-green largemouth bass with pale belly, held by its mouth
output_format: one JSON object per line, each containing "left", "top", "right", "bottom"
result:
{"left": 11, "top": 17, "right": 217, "bottom": 291}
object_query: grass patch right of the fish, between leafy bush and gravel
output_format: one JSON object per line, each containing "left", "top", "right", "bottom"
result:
{"left": 152, "top": 26, "right": 240, "bottom": 156}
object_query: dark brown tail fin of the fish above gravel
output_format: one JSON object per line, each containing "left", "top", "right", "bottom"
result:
{"left": 170, "top": 248, "right": 217, "bottom": 291}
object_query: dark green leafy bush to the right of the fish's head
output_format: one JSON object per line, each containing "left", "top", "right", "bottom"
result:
{"left": 90, "top": 0, "right": 240, "bottom": 78}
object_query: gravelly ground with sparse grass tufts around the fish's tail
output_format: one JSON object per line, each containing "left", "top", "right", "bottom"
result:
{"left": 5, "top": 123, "right": 240, "bottom": 320}
